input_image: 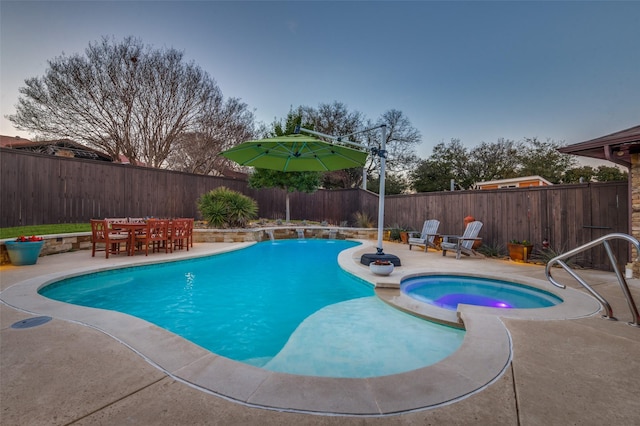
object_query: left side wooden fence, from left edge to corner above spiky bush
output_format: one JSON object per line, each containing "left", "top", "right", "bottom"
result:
{"left": 0, "top": 149, "right": 247, "bottom": 227}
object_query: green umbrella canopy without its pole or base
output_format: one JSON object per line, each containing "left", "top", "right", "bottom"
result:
{"left": 220, "top": 134, "right": 368, "bottom": 172}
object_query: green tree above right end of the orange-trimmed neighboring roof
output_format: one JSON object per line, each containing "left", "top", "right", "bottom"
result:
{"left": 517, "top": 138, "right": 577, "bottom": 183}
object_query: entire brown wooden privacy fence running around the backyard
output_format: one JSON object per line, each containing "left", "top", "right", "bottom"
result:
{"left": 0, "top": 148, "right": 629, "bottom": 269}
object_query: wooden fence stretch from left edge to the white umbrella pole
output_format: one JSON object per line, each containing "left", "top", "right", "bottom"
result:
{"left": 0, "top": 148, "right": 370, "bottom": 228}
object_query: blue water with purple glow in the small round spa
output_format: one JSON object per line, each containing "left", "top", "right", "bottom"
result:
{"left": 400, "top": 275, "right": 562, "bottom": 310}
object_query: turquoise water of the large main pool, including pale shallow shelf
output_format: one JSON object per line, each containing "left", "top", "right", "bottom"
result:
{"left": 40, "top": 240, "right": 464, "bottom": 377}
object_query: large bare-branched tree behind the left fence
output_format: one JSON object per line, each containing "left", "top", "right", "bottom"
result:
{"left": 8, "top": 37, "right": 245, "bottom": 167}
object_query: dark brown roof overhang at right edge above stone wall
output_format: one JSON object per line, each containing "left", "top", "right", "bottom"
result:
{"left": 558, "top": 126, "right": 640, "bottom": 167}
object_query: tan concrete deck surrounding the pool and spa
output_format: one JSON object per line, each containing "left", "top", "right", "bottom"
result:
{"left": 0, "top": 242, "right": 640, "bottom": 425}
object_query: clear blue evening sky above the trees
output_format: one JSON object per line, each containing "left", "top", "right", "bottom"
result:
{"left": 0, "top": 0, "right": 640, "bottom": 162}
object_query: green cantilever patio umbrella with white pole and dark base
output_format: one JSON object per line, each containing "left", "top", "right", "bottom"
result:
{"left": 220, "top": 124, "right": 400, "bottom": 266}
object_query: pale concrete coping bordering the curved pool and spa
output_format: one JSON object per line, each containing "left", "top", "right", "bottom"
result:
{"left": 0, "top": 241, "right": 600, "bottom": 416}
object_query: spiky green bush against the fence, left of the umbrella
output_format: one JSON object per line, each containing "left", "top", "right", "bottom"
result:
{"left": 198, "top": 186, "right": 258, "bottom": 228}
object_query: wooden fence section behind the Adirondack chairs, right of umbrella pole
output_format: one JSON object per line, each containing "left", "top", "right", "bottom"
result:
{"left": 385, "top": 182, "right": 629, "bottom": 270}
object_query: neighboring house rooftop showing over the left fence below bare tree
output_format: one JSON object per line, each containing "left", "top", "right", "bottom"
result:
{"left": 0, "top": 136, "right": 113, "bottom": 162}
